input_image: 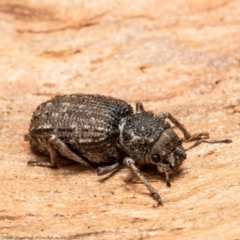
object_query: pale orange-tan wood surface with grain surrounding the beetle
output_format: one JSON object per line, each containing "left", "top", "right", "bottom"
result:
{"left": 0, "top": 0, "right": 240, "bottom": 240}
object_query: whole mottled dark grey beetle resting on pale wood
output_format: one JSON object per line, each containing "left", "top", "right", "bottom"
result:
{"left": 28, "top": 94, "right": 231, "bottom": 205}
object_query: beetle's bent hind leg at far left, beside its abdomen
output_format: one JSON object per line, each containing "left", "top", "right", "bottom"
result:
{"left": 28, "top": 135, "right": 90, "bottom": 168}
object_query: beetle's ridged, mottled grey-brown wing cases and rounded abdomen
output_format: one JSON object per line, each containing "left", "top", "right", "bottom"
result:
{"left": 30, "top": 94, "right": 133, "bottom": 164}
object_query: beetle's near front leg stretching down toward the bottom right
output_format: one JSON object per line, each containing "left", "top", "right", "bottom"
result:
{"left": 123, "top": 157, "right": 163, "bottom": 206}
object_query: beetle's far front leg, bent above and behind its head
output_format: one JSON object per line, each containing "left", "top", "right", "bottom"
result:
{"left": 158, "top": 112, "right": 209, "bottom": 142}
